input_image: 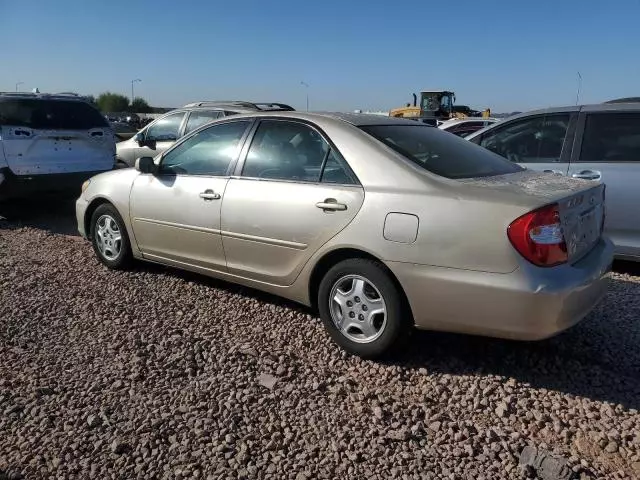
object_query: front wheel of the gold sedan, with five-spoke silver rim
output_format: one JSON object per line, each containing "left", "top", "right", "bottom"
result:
{"left": 91, "top": 203, "right": 131, "bottom": 270}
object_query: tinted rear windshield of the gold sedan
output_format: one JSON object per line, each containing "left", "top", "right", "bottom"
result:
{"left": 360, "top": 124, "right": 523, "bottom": 179}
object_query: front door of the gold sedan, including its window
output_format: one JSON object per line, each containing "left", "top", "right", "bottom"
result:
{"left": 130, "top": 120, "right": 250, "bottom": 271}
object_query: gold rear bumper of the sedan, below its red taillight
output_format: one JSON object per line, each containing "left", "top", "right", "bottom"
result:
{"left": 387, "top": 239, "right": 613, "bottom": 340}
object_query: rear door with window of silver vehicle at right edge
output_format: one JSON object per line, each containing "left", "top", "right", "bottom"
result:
{"left": 569, "top": 111, "right": 640, "bottom": 256}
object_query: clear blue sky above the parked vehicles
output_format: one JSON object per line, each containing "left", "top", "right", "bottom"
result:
{"left": 0, "top": 0, "right": 640, "bottom": 112}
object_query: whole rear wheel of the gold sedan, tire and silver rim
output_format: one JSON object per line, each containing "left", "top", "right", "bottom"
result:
{"left": 318, "top": 258, "right": 409, "bottom": 358}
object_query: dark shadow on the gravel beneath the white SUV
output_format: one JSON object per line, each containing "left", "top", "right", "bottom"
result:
{"left": 0, "top": 195, "right": 78, "bottom": 235}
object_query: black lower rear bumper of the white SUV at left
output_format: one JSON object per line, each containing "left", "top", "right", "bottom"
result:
{"left": 0, "top": 168, "right": 109, "bottom": 200}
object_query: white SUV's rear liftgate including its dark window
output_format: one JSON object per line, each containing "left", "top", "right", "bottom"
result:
{"left": 0, "top": 97, "right": 115, "bottom": 176}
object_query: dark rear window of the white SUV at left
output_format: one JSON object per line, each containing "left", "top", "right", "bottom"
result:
{"left": 0, "top": 98, "right": 109, "bottom": 130}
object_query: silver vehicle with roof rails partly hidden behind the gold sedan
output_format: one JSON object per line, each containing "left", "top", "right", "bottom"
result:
{"left": 116, "top": 101, "right": 294, "bottom": 168}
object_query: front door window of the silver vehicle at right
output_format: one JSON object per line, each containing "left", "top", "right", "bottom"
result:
{"left": 480, "top": 113, "right": 571, "bottom": 163}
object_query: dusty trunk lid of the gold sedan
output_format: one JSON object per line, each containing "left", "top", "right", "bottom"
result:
{"left": 458, "top": 170, "right": 605, "bottom": 263}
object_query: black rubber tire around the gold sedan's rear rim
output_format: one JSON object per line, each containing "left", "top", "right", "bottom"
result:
{"left": 318, "top": 258, "right": 411, "bottom": 359}
